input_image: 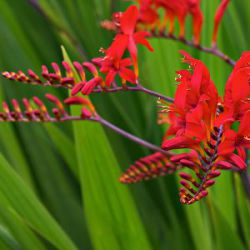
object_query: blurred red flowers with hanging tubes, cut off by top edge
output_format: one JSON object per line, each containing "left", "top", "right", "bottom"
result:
{"left": 137, "top": 0, "right": 230, "bottom": 44}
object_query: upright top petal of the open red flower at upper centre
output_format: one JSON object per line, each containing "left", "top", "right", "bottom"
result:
{"left": 121, "top": 5, "right": 139, "bottom": 35}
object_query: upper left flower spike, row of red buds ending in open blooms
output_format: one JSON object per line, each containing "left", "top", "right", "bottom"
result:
{"left": 2, "top": 6, "right": 153, "bottom": 95}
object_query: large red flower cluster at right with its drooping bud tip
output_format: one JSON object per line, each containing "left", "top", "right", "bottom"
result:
{"left": 162, "top": 52, "right": 250, "bottom": 204}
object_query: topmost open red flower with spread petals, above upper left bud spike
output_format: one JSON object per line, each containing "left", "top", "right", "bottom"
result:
{"left": 106, "top": 6, "right": 153, "bottom": 77}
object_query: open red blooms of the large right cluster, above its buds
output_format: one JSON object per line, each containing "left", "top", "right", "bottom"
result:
{"left": 162, "top": 52, "right": 250, "bottom": 167}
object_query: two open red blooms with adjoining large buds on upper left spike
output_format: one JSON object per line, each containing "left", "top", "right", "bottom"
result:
{"left": 73, "top": 5, "right": 153, "bottom": 95}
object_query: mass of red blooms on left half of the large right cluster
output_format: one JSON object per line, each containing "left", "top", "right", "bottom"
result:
{"left": 162, "top": 51, "right": 218, "bottom": 150}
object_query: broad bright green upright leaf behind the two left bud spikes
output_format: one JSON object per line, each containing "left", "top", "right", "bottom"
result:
{"left": 63, "top": 49, "right": 151, "bottom": 249}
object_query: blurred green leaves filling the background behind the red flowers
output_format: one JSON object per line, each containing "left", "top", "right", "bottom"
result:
{"left": 0, "top": 0, "right": 250, "bottom": 250}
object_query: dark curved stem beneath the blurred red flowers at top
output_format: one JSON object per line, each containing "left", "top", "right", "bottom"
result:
{"left": 150, "top": 32, "right": 235, "bottom": 66}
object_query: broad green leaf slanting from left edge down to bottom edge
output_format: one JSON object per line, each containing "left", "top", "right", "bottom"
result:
{"left": 0, "top": 156, "right": 76, "bottom": 250}
